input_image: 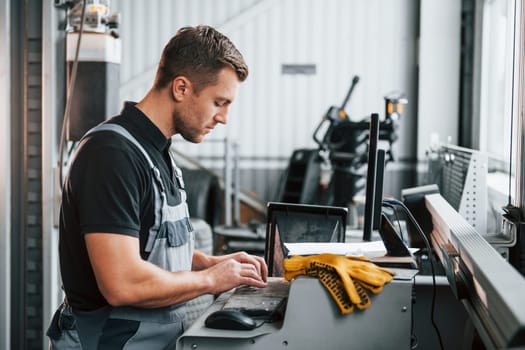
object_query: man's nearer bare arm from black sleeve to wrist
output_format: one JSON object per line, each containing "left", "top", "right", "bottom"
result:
{"left": 85, "top": 233, "right": 217, "bottom": 308}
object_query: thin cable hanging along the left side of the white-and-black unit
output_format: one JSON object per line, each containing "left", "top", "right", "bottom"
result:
{"left": 58, "top": 0, "right": 86, "bottom": 187}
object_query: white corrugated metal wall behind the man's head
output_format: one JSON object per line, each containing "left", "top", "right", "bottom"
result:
{"left": 112, "top": 0, "right": 418, "bottom": 168}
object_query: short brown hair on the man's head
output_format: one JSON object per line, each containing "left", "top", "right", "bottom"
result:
{"left": 154, "top": 26, "right": 248, "bottom": 93}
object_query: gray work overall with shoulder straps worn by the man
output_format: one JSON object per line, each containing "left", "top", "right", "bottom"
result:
{"left": 47, "top": 124, "right": 194, "bottom": 350}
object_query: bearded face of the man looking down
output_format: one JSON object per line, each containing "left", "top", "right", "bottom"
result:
{"left": 173, "top": 67, "right": 240, "bottom": 143}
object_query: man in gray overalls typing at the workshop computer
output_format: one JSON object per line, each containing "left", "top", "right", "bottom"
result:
{"left": 48, "top": 26, "right": 268, "bottom": 350}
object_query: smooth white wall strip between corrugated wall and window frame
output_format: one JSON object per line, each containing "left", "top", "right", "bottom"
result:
{"left": 417, "top": 0, "right": 461, "bottom": 160}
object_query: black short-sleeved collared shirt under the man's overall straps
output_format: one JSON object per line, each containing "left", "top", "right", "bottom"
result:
{"left": 59, "top": 102, "right": 181, "bottom": 310}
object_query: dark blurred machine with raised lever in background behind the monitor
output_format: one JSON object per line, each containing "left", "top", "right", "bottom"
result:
{"left": 278, "top": 76, "right": 407, "bottom": 207}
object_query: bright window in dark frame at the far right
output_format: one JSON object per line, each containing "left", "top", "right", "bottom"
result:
{"left": 478, "top": 0, "right": 519, "bottom": 232}
